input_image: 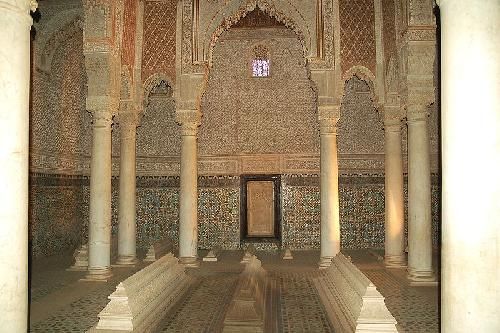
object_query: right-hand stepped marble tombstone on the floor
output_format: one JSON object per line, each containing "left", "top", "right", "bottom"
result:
{"left": 314, "top": 253, "right": 397, "bottom": 333}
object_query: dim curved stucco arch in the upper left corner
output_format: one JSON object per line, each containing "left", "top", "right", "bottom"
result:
{"left": 35, "top": 9, "right": 83, "bottom": 73}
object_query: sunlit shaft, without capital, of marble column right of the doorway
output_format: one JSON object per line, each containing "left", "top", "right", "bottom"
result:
{"left": 320, "top": 132, "right": 340, "bottom": 266}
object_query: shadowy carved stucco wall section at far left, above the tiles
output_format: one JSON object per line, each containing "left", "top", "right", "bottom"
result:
{"left": 30, "top": 25, "right": 92, "bottom": 158}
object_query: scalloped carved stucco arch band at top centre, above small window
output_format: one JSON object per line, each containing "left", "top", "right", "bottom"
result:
{"left": 201, "top": 0, "right": 312, "bottom": 67}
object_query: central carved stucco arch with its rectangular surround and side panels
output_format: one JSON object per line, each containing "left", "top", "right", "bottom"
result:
{"left": 181, "top": 0, "right": 334, "bottom": 73}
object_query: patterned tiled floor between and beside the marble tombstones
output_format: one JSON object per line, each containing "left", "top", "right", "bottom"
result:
{"left": 30, "top": 251, "right": 439, "bottom": 333}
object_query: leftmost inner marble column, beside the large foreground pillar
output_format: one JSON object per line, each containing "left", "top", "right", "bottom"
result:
{"left": 85, "top": 110, "right": 112, "bottom": 281}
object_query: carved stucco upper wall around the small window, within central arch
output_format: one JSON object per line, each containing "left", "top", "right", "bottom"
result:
{"left": 198, "top": 27, "right": 319, "bottom": 155}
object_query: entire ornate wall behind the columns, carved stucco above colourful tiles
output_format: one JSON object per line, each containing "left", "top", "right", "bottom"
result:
{"left": 30, "top": 1, "right": 440, "bottom": 256}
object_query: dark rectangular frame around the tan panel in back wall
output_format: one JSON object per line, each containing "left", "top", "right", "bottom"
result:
{"left": 240, "top": 174, "right": 281, "bottom": 245}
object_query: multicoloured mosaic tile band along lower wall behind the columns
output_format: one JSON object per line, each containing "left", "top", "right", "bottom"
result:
{"left": 30, "top": 175, "right": 441, "bottom": 257}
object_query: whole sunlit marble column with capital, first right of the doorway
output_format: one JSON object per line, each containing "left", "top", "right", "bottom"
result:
{"left": 319, "top": 106, "right": 340, "bottom": 268}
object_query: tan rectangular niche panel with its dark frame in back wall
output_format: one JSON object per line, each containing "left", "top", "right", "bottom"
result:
{"left": 240, "top": 175, "right": 281, "bottom": 243}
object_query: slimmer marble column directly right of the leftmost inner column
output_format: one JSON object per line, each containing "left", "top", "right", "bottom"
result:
{"left": 116, "top": 112, "right": 138, "bottom": 265}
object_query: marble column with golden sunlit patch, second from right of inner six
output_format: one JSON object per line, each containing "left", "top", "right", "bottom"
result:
{"left": 384, "top": 116, "right": 406, "bottom": 267}
